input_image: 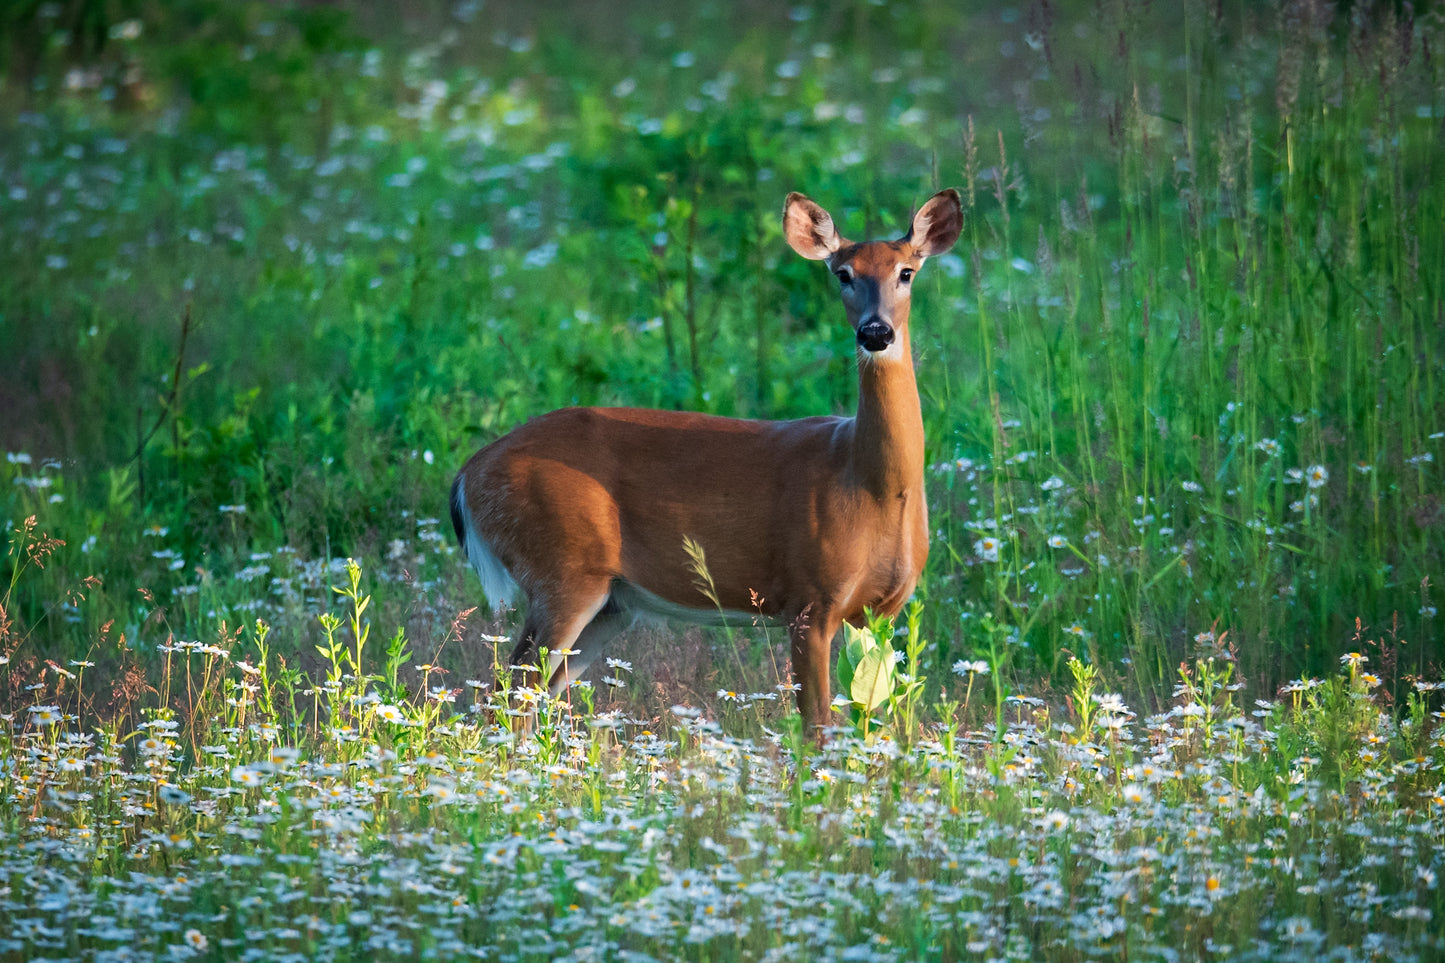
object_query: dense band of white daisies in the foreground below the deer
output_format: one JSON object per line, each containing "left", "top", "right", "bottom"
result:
{"left": 8, "top": 526, "right": 1445, "bottom": 960}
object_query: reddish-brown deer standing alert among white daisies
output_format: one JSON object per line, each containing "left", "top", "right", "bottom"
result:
{"left": 451, "top": 189, "right": 962, "bottom": 742}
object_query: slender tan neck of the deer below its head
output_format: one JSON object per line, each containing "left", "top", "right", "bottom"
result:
{"left": 853, "top": 325, "right": 923, "bottom": 499}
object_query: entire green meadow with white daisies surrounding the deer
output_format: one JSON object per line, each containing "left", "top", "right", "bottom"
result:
{"left": 0, "top": 0, "right": 1445, "bottom": 960}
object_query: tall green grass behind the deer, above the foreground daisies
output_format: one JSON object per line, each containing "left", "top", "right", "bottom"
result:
{"left": 0, "top": 3, "right": 1445, "bottom": 708}
